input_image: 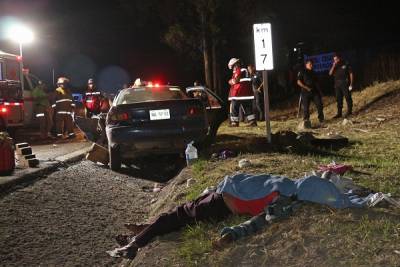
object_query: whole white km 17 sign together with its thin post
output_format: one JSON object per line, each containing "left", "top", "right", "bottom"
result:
{"left": 253, "top": 23, "right": 274, "bottom": 143}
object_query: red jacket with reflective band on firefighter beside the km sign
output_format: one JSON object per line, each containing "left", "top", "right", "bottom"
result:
{"left": 228, "top": 67, "right": 254, "bottom": 100}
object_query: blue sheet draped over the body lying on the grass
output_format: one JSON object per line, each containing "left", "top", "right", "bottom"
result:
{"left": 217, "top": 173, "right": 366, "bottom": 209}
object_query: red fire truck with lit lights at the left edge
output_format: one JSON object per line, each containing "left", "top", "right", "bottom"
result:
{"left": 0, "top": 50, "right": 39, "bottom": 133}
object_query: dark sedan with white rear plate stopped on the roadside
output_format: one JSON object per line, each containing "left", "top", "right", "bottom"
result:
{"left": 106, "top": 85, "right": 222, "bottom": 170}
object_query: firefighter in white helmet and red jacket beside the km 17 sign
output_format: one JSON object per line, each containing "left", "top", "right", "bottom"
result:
{"left": 228, "top": 58, "right": 257, "bottom": 127}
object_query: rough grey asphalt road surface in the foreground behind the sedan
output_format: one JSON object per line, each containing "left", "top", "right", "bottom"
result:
{"left": 0, "top": 159, "right": 184, "bottom": 266}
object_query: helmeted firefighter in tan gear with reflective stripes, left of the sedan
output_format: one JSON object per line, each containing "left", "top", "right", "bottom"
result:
{"left": 53, "top": 77, "right": 75, "bottom": 138}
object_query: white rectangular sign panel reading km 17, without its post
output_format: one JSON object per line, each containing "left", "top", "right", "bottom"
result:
{"left": 253, "top": 23, "right": 274, "bottom": 70}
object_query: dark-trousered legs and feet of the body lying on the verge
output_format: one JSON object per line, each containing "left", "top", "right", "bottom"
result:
{"left": 107, "top": 192, "right": 232, "bottom": 259}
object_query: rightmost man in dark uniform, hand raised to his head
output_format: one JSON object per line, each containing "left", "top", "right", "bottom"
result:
{"left": 329, "top": 54, "right": 353, "bottom": 118}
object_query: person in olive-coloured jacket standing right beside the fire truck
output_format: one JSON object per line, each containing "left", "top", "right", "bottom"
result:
{"left": 32, "top": 81, "right": 52, "bottom": 139}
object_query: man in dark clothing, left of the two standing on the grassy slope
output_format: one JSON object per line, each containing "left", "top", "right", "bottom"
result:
{"left": 297, "top": 60, "right": 324, "bottom": 122}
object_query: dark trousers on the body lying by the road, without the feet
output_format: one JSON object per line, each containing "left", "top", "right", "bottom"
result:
{"left": 135, "top": 192, "right": 232, "bottom": 247}
